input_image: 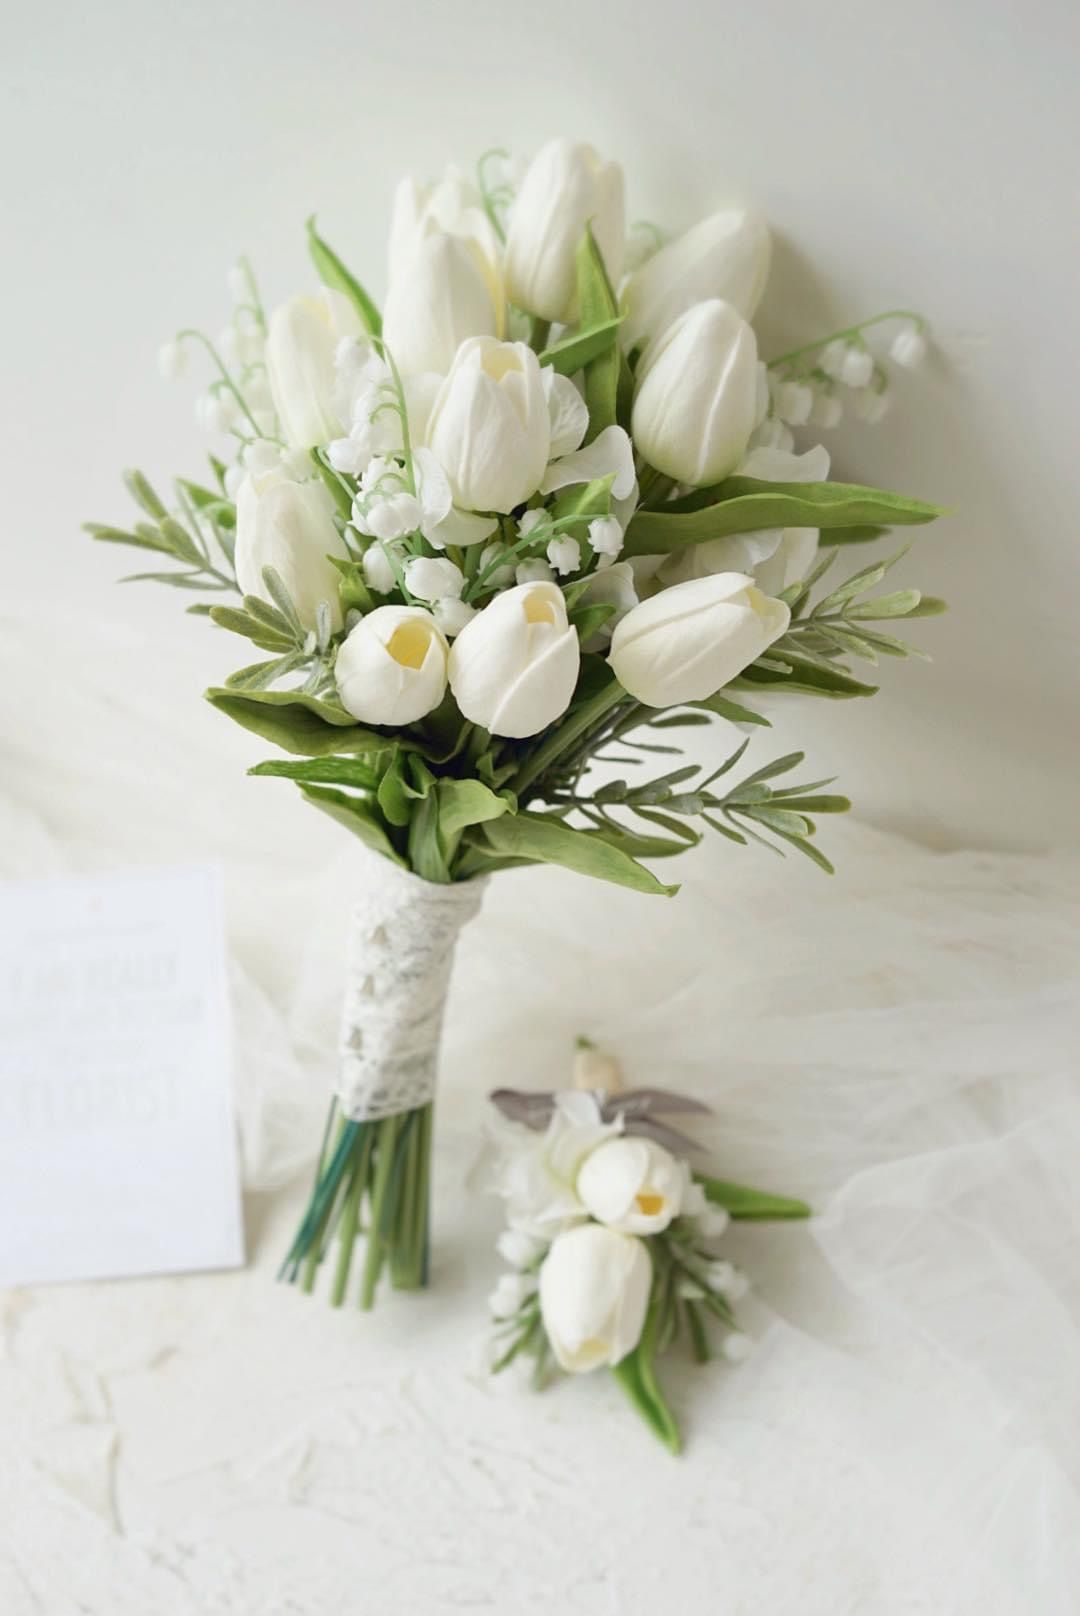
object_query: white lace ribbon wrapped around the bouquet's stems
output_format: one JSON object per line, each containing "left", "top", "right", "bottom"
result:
{"left": 336, "top": 856, "right": 487, "bottom": 1122}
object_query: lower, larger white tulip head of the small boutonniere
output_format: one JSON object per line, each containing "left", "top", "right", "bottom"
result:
{"left": 540, "top": 1223, "right": 653, "bottom": 1374}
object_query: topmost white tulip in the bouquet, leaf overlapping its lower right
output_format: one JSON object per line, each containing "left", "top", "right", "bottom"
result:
{"left": 506, "top": 141, "right": 626, "bottom": 322}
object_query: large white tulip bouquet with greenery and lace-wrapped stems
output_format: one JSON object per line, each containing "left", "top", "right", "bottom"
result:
{"left": 89, "top": 141, "right": 941, "bottom": 1306}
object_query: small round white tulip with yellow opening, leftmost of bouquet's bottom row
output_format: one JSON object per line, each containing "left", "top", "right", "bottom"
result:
{"left": 335, "top": 606, "right": 449, "bottom": 729}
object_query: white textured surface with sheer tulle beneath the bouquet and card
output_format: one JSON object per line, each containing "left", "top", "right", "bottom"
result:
{"left": 0, "top": 601, "right": 1080, "bottom": 1616}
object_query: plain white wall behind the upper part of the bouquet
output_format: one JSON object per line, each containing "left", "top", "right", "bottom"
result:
{"left": 0, "top": 0, "right": 1080, "bottom": 848}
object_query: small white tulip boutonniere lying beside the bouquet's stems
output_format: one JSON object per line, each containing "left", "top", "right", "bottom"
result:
{"left": 485, "top": 1044, "right": 810, "bottom": 1453}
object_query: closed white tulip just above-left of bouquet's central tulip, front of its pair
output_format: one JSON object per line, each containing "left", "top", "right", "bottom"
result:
{"left": 383, "top": 233, "right": 500, "bottom": 375}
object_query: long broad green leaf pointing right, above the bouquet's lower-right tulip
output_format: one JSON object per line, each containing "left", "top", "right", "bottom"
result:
{"left": 622, "top": 477, "right": 944, "bottom": 556}
